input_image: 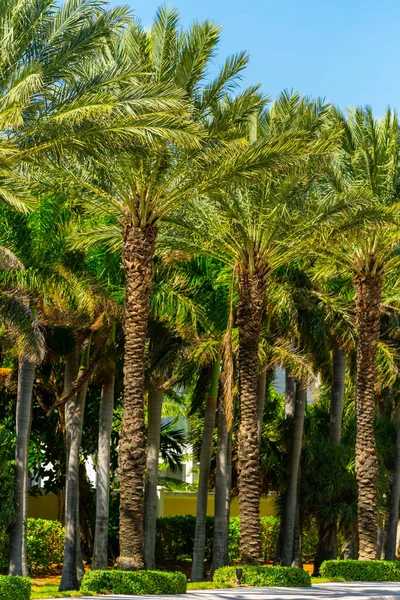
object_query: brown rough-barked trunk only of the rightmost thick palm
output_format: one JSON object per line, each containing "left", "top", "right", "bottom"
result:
{"left": 355, "top": 274, "right": 382, "bottom": 560}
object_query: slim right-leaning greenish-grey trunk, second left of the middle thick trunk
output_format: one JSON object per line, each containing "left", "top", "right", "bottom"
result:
{"left": 191, "top": 359, "right": 221, "bottom": 581}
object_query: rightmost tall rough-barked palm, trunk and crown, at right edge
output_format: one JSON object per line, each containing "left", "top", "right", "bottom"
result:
{"left": 312, "top": 107, "right": 400, "bottom": 560}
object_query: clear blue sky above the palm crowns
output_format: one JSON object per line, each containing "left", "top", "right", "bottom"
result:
{"left": 108, "top": 0, "right": 400, "bottom": 116}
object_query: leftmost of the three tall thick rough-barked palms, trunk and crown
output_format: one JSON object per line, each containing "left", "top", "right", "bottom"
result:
{"left": 63, "top": 9, "right": 309, "bottom": 568}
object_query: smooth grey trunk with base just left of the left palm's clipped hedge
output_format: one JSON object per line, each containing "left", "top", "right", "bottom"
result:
{"left": 59, "top": 382, "right": 88, "bottom": 592}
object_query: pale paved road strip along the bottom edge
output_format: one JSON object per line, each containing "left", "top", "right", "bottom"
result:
{"left": 50, "top": 582, "right": 400, "bottom": 600}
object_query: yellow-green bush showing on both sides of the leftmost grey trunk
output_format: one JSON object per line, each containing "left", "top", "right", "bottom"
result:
{"left": 0, "top": 519, "right": 65, "bottom": 573}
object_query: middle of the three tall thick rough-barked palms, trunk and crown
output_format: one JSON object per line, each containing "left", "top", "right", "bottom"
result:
{"left": 161, "top": 94, "right": 336, "bottom": 563}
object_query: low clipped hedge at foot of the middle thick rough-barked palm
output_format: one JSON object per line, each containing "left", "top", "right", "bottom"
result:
{"left": 213, "top": 566, "right": 311, "bottom": 587}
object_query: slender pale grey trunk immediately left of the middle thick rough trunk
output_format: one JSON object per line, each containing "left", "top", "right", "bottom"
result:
{"left": 210, "top": 394, "right": 231, "bottom": 576}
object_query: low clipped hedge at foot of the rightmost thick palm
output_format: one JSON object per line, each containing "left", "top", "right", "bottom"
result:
{"left": 320, "top": 560, "right": 400, "bottom": 581}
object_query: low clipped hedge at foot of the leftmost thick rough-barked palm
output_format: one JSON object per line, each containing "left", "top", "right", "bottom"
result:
{"left": 81, "top": 570, "right": 187, "bottom": 600}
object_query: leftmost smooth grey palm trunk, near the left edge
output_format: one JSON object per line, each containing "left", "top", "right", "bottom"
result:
{"left": 9, "top": 355, "right": 35, "bottom": 577}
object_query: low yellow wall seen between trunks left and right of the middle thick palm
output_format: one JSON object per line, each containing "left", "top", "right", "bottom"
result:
{"left": 159, "top": 490, "right": 275, "bottom": 517}
